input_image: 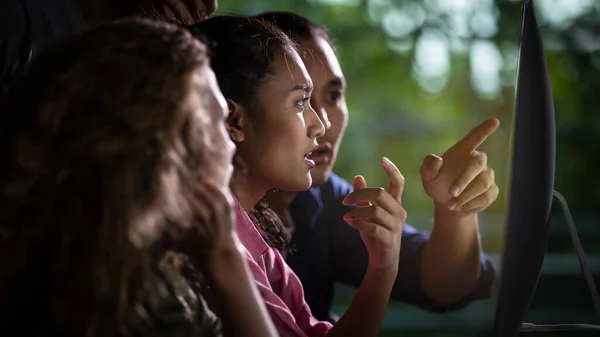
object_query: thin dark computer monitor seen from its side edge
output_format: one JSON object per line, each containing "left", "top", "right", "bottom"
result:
{"left": 494, "top": 0, "right": 556, "bottom": 337}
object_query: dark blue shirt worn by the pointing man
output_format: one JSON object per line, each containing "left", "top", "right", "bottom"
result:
{"left": 287, "top": 174, "right": 496, "bottom": 320}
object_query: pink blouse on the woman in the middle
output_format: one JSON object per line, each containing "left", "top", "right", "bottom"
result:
{"left": 235, "top": 198, "right": 333, "bottom": 337}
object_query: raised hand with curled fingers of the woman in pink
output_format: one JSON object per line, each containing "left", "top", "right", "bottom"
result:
{"left": 343, "top": 158, "right": 406, "bottom": 269}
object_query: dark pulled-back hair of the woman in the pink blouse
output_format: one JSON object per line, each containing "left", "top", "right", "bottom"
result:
{"left": 187, "top": 15, "right": 298, "bottom": 254}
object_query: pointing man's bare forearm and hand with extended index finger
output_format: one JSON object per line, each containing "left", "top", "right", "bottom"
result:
{"left": 421, "top": 118, "right": 499, "bottom": 304}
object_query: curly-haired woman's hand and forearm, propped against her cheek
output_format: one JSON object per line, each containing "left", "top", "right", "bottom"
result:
{"left": 165, "top": 181, "right": 278, "bottom": 337}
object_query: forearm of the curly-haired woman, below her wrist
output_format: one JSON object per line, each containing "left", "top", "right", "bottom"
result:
{"left": 209, "top": 238, "right": 278, "bottom": 337}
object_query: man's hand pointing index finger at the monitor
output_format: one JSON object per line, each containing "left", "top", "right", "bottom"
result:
{"left": 421, "top": 118, "right": 500, "bottom": 214}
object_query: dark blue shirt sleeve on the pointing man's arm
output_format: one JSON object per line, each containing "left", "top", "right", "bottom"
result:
{"left": 328, "top": 177, "right": 496, "bottom": 312}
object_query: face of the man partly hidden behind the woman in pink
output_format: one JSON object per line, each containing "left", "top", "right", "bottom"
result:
{"left": 299, "top": 37, "right": 348, "bottom": 186}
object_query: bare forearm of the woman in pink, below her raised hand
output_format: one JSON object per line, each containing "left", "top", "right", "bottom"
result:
{"left": 327, "top": 267, "right": 397, "bottom": 337}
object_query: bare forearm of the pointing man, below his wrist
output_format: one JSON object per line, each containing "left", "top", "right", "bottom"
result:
{"left": 420, "top": 206, "right": 481, "bottom": 305}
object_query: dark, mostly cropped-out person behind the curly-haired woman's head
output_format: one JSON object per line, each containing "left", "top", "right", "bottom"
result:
{"left": 0, "top": 0, "right": 217, "bottom": 96}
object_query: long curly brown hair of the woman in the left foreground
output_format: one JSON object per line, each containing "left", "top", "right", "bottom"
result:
{"left": 0, "top": 20, "right": 210, "bottom": 336}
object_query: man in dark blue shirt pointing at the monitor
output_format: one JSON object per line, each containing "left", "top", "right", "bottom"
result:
{"left": 261, "top": 13, "right": 498, "bottom": 320}
